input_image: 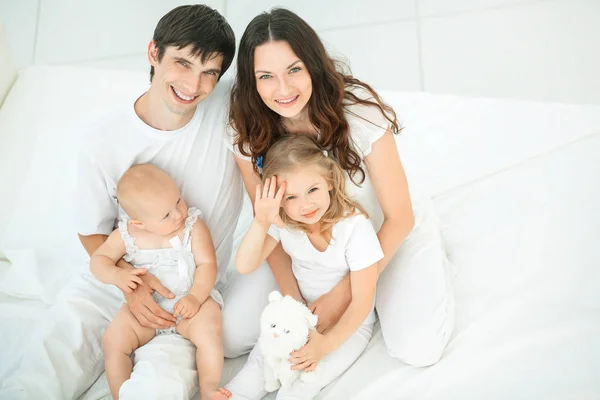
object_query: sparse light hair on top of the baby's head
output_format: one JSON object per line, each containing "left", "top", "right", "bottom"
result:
{"left": 117, "top": 164, "right": 177, "bottom": 220}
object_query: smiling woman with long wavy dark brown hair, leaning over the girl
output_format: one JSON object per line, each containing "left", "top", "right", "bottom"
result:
{"left": 229, "top": 8, "right": 454, "bottom": 366}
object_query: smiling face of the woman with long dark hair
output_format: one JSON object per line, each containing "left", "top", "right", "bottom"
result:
{"left": 254, "top": 41, "right": 312, "bottom": 118}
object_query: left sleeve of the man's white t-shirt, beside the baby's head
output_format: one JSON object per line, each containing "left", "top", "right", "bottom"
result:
{"left": 75, "top": 149, "right": 119, "bottom": 236}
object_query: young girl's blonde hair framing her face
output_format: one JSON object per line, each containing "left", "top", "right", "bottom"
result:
{"left": 262, "top": 134, "right": 368, "bottom": 232}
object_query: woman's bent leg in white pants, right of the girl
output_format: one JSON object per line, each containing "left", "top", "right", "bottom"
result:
{"left": 375, "top": 195, "right": 455, "bottom": 367}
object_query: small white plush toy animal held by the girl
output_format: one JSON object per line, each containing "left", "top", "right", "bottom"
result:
{"left": 259, "top": 291, "right": 322, "bottom": 392}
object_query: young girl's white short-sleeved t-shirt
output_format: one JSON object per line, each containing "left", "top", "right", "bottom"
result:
{"left": 268, "top": 214, "right": 383, "bottom": 323}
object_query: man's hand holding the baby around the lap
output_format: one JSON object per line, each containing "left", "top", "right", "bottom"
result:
{"left": 119, "top": 261, "right": 177, "bottom": 329}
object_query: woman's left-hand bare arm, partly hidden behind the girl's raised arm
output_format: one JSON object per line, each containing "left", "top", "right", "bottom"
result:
{"left": 235, "top": 156, "right": 304, "bottom": 302}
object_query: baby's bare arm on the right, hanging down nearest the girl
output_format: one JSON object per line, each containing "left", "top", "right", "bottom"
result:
{"left": 189, "top": 219, "right": 217, "bottom": 304}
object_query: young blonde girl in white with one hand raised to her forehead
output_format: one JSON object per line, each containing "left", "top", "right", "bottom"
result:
{"left": 226, "top": 135, "right": 383, "bottom": 399}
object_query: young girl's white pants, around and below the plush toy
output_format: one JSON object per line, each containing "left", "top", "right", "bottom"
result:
{"left": 225, "top": 324, "right": 373, "bottom": 400}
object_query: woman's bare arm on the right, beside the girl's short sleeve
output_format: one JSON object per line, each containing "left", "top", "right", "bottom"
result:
{"left": 365, "top": 129, "right": 415, "bottom": 273}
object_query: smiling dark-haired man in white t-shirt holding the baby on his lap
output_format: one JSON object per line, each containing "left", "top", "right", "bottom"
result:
{"left": 0, "top": 5, "right": 277, "bottom": 399}
